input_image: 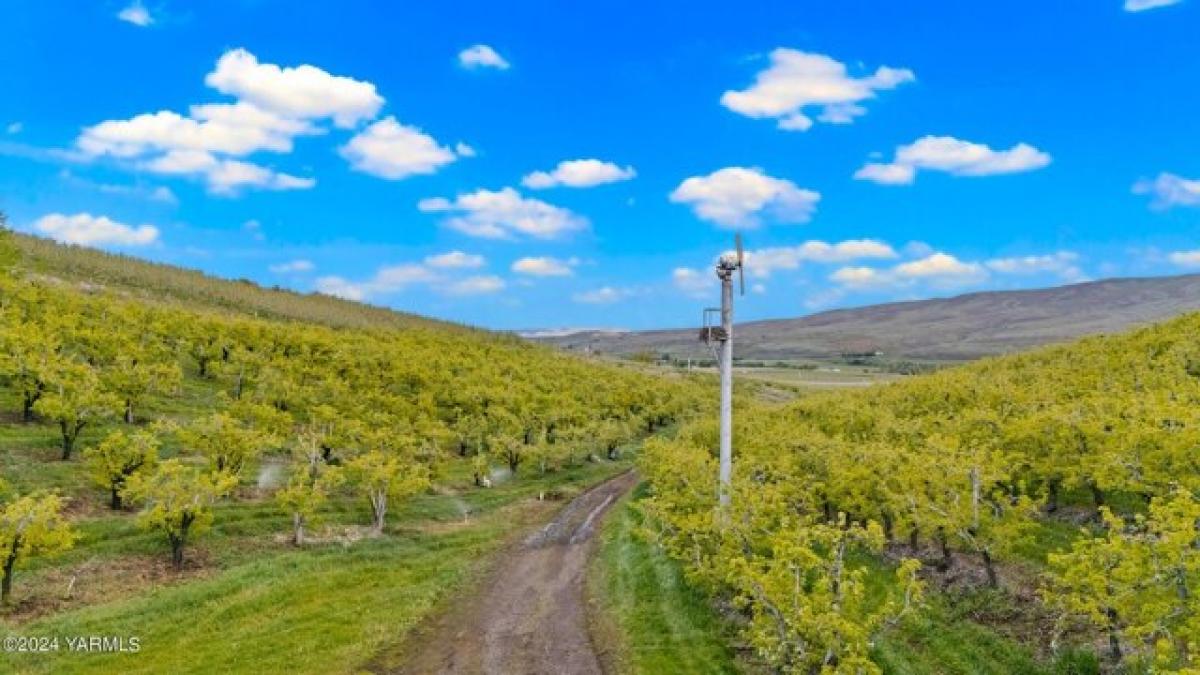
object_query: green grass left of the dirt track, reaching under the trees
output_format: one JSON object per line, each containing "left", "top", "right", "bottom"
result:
{"left": 0, "top": 432, "right": 629, "bottom": 674}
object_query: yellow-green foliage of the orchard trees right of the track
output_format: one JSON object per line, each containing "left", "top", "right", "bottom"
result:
{"left": 643, "top": 315, "right": 1200, "bottom": 671}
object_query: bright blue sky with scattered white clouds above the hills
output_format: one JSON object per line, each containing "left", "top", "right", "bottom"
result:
{"left": 0, "top": 0, "right": 1200, "bottom": 328}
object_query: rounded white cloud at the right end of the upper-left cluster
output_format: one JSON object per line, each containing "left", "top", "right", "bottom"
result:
{"left": 340, "top": 117, "right": 458, "bottom": 180}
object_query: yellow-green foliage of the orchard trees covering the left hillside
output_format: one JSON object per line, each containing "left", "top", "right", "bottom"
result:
{"left": 0, "top": 248, "right": 697, "bottom": 565}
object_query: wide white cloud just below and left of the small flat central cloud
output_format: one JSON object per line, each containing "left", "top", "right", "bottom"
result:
{"left": 416, "top": 187, "right": 588, "bottom": 239}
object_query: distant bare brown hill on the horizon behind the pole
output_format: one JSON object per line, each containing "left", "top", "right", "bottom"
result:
{"left": 539, "top": 270, "right": 1200, "bottom": 360}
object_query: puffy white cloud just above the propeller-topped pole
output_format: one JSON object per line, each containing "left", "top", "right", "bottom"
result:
{"left": 671, "top": 167, "right": 821, "bottom": 228}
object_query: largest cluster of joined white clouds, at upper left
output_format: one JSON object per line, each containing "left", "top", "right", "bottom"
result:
{"left": 76, "top": 49, "right": 408, "bottom": 195}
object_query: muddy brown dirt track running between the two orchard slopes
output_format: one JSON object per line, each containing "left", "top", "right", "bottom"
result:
{"left": 397, "top": 472, "right": 637, "bottom": 675}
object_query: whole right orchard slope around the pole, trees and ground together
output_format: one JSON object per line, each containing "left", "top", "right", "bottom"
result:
{"left": 642, "top": 313, "right": 1200, "bottom": 674}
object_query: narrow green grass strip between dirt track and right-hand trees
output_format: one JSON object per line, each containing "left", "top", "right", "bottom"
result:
{"left": 588, "top": 489, "right": 740, "bottom": 674}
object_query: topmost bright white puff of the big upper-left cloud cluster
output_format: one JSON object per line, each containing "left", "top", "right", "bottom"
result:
{"left": 204, "top": 49, "right": 384, "bottom": 129}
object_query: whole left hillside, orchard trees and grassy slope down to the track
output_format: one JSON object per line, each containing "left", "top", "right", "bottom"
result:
{"left": 0, "top": 228, "right": 703, "bottom": 674}
